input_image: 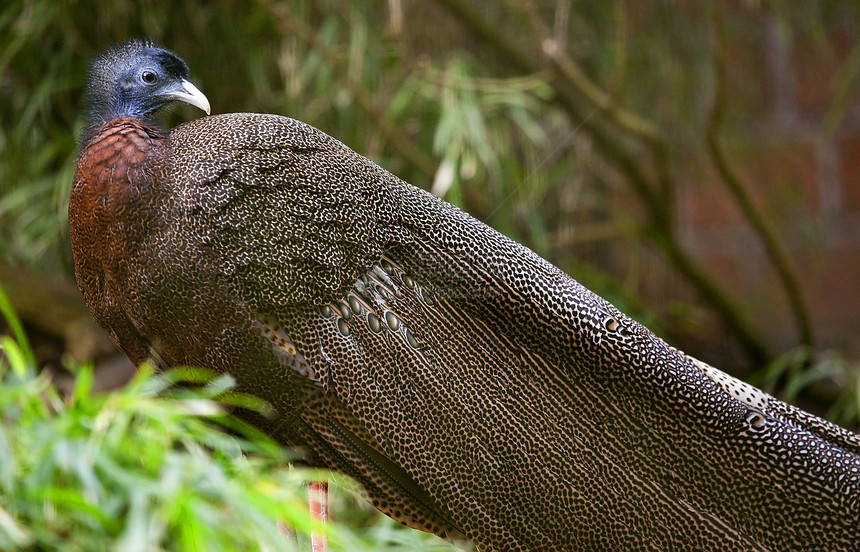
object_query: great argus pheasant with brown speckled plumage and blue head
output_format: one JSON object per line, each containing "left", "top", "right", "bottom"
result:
{"left": 69, "top": 41, "right": 860, "bottom": 551}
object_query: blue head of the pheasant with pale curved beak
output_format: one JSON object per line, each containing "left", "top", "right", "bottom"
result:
{"left": 87, "top": 40, "right": 210, "bottom": 132}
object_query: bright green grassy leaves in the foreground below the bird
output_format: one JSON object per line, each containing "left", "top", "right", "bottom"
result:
{"left": 0, "top": 294, "right": 455, "bottom": 552}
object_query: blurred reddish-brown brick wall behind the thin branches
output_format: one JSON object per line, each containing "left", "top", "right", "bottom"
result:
{"left": 678, "top": 10, "right": 860, "bottom": 358}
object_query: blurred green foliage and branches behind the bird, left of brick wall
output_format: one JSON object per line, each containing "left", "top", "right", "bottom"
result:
{"left": 0, "top": 0, "right": 860, "bottom": 444}
